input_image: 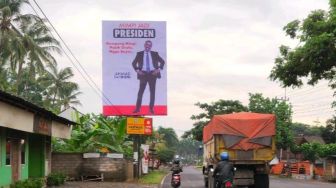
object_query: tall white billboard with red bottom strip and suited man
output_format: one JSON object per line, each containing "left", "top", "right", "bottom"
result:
{"left": 102, "top": 21, "right": 167, "bottom": 116}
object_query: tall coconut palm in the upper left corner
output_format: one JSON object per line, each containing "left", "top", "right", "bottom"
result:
{"left": 0, "top": 0, "right": 60, "bottom": 95}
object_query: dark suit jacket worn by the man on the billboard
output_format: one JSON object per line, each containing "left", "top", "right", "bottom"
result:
{"left": 132, "top": 51, "right": 165, "bottom": 79}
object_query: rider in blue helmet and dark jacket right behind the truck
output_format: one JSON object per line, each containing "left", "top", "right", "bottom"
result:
{"left": 213, "top": 152, "right": 234, "bottom": 185}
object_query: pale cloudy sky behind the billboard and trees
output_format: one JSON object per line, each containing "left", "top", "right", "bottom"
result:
{"left": 24, "top": 0, "right": 333, "bottom": 136}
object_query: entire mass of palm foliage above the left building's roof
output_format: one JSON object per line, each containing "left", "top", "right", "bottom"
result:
{"left": 0, "top": 0, "right": 80, "bottom": 113}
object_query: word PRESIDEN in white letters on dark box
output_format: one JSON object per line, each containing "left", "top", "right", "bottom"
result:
{"left": 113, "top": 29, "right": 155, "bottom": 38}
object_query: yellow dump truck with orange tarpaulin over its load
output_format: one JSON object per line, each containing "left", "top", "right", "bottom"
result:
{"left": 203, "top": 112, "right": 276, "bottom": 188}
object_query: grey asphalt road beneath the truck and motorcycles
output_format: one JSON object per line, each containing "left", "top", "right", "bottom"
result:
{"left": 161, "top": 167, "right": 336, "bottom": 188}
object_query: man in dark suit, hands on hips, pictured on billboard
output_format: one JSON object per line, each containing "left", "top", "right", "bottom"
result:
{"left": 132, "top": 40, "right": 165, "bottom": 114}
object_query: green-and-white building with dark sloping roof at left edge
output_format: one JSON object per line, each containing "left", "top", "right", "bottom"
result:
{"left": 0, "top": 90, "right": 76, "bottom": 187}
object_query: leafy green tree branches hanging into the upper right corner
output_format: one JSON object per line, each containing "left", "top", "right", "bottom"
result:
{"left": 270, "top": 0, "right": 336, "bottom": 105}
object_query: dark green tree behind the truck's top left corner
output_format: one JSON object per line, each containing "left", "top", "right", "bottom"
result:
{"left": 182, "top": 100, "right": 248, "bottom": 141}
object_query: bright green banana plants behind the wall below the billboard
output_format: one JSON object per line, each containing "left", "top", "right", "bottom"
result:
{"left": 53, "top": 114, "right": 132, "bottom": 156}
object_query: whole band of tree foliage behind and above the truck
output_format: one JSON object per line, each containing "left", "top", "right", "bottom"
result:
{"left": 183, "top": 93, "right": 293, "bottom": 149}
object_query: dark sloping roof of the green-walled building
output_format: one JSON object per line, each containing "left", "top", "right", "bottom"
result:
{"left": 0, "top": 90, "right": 77, "bottom": 125}
